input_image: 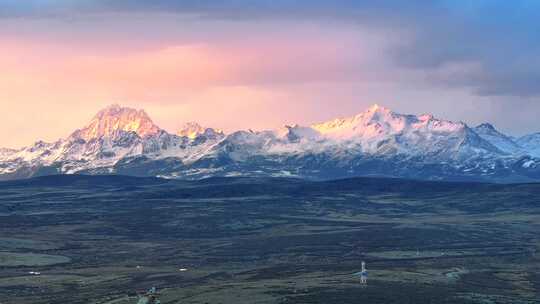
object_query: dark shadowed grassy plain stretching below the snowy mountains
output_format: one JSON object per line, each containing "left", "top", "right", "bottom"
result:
{"left": 0, "top": 175, "right": 540, "bottom": 304}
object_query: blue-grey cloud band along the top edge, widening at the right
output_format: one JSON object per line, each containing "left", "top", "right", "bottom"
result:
{"left": 0, "top": 0, "right": 540, "bottom": 97}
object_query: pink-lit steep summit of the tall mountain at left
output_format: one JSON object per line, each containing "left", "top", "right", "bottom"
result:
{"left": 72, "top": 104, "right": 161, "bottom": 141}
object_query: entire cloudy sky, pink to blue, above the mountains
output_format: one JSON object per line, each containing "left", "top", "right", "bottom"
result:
{"left": 0, "top": 0, "right": 540, "bottom": 147}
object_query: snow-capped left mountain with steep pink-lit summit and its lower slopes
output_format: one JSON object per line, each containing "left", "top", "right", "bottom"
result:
{"left": 0, "top": 105, "right": 223, "bottom": 179}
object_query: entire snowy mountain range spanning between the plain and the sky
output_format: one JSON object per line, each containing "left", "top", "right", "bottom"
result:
{"left": 0, "top": 105, "right": 540, "bottom": 182}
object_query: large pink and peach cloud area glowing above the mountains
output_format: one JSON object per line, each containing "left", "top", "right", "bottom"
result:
{"left": 4, "top": 16, "right": 520, "bottom": 147}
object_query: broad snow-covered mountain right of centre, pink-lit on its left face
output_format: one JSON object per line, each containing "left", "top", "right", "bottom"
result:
{"left": 312, "top": 105, "right": 501, "bottom": 159}
